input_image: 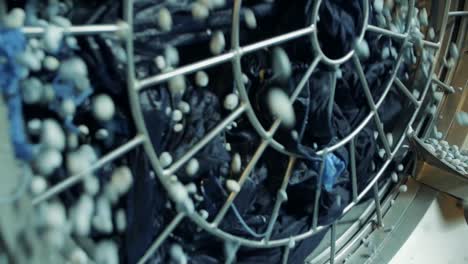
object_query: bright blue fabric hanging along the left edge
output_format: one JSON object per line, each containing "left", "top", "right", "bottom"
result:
{"left": 0, "top": 29, "right": 33, "bottom": 160}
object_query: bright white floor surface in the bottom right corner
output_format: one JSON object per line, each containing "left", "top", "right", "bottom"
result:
{"left": 390, "top": 194, "right": 468, "bottom": 264}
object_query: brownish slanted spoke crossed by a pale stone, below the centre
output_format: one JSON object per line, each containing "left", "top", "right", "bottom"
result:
{"left": 211, "top": 140, "right": 268, "bottom": 227}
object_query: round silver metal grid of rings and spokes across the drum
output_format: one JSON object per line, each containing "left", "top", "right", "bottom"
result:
{"left": 23, "top": 0, "right": 466, "bottom": 263}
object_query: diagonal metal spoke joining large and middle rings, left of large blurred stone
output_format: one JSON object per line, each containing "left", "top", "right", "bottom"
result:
{"left": 164, "top": 104, "right": 246, "bottom": 176}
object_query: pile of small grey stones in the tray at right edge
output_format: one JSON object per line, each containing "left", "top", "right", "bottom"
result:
{"left": 424, "top": 138, "right": 468, "bottom": 174}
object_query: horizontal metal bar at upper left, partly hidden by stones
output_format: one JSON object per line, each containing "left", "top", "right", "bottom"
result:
{"left": 21, "top": 24, "right": 122, "bottom": 36}
